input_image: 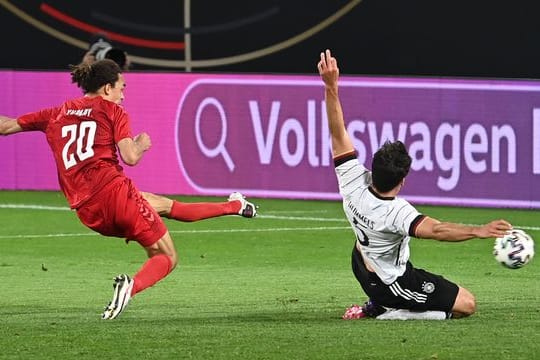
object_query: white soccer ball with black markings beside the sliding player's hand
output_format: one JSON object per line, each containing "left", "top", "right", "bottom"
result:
{"left": 493, "top": 229, "right": 534, "bottom": 269}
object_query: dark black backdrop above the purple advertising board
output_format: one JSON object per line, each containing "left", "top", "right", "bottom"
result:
{"left": 0, "top": 0, "right": 540, "bottom": 78}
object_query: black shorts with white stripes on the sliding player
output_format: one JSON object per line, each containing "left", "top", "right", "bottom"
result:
{"left": 352, "top": 246, "right": 459, "bottom": 312}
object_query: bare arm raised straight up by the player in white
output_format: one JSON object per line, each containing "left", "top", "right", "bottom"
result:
{"left": 317, "top": 50, "right": 354, "bottom": 157}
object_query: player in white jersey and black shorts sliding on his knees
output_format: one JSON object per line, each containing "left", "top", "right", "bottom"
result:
{"left": 317, "top": 50, "right": 512, "bottom": 320}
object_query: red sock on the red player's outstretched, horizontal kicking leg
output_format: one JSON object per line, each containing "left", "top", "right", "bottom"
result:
{"left": 167, "top": 200, "right": 241, "bottom": 222}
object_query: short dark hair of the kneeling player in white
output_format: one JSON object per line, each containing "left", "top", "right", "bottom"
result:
{"left": 371, "top": 140, "right": 412, "bottom": 192}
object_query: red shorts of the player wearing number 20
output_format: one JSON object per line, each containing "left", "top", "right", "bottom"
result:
{"left": 77, "top": 178, "right": 167, "bottom": 247}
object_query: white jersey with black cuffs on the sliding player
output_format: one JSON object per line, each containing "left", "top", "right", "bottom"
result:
{"left": 336, "top": 154, "right": 424, "bottom": 285}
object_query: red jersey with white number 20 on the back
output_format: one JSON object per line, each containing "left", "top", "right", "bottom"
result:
{"left": 17, "top": 96, "right": 132, "bottom": 209}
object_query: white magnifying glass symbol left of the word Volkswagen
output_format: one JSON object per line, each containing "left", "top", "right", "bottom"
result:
{"left": 195, "top": 97, "right": 234, "bottom": 172}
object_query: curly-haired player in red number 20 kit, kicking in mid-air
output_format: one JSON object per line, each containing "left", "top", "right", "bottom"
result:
{"left": 0, "top": 60, "right": 256, "bottom": 319}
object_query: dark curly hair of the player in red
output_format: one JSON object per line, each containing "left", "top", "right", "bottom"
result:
{"left": 70, "top": 59, "right": 122, "bottom": 94}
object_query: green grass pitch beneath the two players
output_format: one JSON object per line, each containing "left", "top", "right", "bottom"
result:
{"left": 0, "top": 192, "right": 540, "bottom": 360}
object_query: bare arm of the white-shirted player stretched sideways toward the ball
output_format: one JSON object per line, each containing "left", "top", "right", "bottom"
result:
{"left": 416, "top": 217, "right": 512, "bottom": 241}
